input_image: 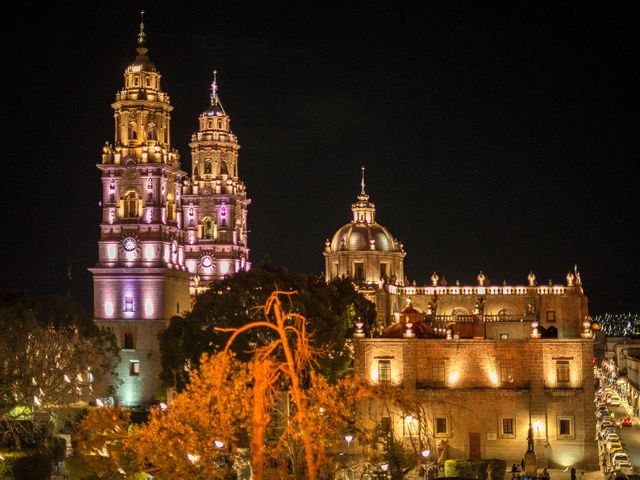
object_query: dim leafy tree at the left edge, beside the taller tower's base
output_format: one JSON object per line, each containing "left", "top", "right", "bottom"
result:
{"left": 0, "top": 293, "right": 117, "bottom": 447}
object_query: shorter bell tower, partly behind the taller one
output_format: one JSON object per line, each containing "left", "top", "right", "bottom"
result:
{"left": 182, "top": 71, "right": 251, "bottom": 296}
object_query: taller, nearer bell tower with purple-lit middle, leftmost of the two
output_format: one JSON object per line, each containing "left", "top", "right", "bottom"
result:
{"left": 90, "top": 12, "right": 190, "bottom": 405}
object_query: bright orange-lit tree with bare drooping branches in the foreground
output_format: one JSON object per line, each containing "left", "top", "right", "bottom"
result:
{"left": 78, "top": 292, "right": 367, "bottom": 480}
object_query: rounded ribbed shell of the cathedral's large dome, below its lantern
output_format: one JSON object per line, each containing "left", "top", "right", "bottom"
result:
{"left": 331, "top": 222, "right": 396, "bottom": 252}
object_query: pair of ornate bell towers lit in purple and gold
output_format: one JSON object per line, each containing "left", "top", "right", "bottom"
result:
{"left": 90, "top": 15, "right": 251, "bottom": 406}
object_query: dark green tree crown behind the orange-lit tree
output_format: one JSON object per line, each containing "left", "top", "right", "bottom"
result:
{"left": 160, "top": 266, "right": 376, "bottom": 390}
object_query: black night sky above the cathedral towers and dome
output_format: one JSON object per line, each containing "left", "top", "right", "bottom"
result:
{"left": 0, "top": 1, "right": 640, "bottom": 313}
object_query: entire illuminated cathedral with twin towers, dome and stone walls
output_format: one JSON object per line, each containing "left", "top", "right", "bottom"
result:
{"left": 90, "top": 14, "right": 597, "bottom": 467}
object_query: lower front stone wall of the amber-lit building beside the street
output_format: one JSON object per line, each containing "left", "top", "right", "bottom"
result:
{"left": 355, "top": 339, "right": 598, "bottom": 468}
